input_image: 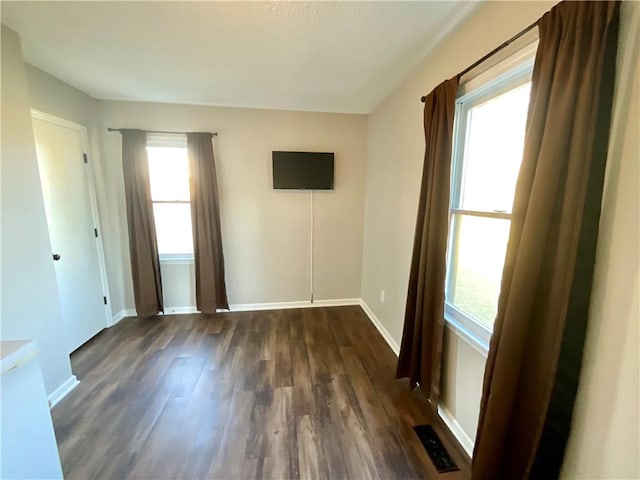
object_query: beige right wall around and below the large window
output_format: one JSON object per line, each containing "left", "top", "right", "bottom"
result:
{"left": 362, "top": 2, "right": 555, "bottom": 439}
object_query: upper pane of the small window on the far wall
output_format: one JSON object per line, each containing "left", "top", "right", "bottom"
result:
{"left": 147, "top": 147, "right": 189, "bottom": 201}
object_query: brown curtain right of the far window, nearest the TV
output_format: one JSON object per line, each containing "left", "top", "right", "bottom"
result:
{"left": 187, "top": 133, "right": 229, "bottom": 313}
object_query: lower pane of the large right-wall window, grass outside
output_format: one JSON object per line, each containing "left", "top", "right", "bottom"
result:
{"left": 447, "top": 215, "right": 511, "bottom": 329}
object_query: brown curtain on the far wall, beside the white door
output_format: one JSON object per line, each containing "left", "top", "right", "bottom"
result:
{"left": 121, "top": 130, "right": 163, "bottom": 317}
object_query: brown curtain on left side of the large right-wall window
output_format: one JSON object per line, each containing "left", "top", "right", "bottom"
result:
{"left": 396, "top": 77, "right": 458, "bottom": 409}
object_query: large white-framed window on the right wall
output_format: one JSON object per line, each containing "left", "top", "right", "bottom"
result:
{"left": 445, "top": 62, "right": 532, "bottom": 349}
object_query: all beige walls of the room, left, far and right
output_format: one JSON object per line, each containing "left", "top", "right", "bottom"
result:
{"left": 7, "top": 1, "right": 640, "bottom": 478}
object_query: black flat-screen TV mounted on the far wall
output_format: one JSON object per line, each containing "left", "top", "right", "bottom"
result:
{"left": 272, "top": 151, "right": 334, "bottom": 190}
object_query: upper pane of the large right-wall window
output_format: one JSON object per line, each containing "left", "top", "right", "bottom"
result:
{"left": 460, "top": 83, "right": 531, "bottom": 212}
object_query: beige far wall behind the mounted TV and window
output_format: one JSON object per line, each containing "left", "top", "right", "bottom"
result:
{"left": 94, "top": 101, "right": 366, "bottom": 311}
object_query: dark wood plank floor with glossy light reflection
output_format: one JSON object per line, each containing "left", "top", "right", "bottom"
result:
{"left": 52, "top": 306, "right": 465, "bottom": 480}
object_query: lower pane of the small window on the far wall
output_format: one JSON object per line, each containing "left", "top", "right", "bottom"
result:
{"left": 153, "top": 203, "right": 193, "bottom": 254}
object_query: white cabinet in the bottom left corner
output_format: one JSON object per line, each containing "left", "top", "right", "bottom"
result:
{"left": 0, "top": 340, "right": 62, "bottom": 479}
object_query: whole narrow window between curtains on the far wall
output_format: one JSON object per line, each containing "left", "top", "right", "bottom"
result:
{"left": 147, "top": 134, "right": 193, "bottom": 263}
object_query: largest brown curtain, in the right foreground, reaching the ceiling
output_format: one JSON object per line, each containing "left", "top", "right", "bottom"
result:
{"left": 472, "top": 2, "right": 619, "bottom": 480}
